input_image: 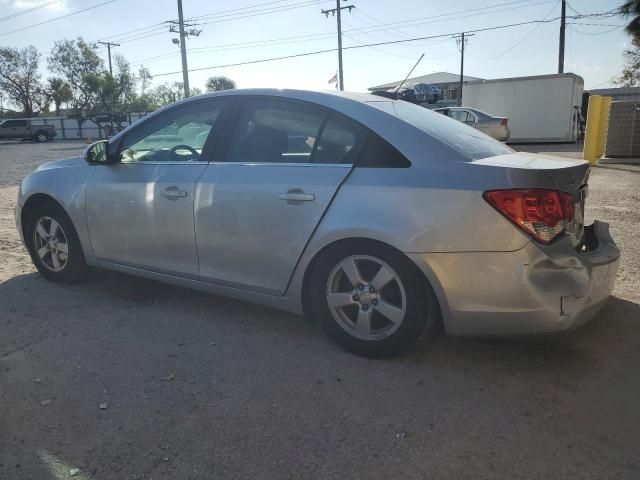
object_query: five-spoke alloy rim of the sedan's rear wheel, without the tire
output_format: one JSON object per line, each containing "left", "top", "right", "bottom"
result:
{"left": 326, "top": 255, "right": 407, "bottom": 340}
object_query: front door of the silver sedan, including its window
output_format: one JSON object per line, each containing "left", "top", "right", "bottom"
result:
{"left": 86, "top": 100, "right": 223, "bottom": 278}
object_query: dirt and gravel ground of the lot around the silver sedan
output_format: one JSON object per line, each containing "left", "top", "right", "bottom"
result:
{"left": 0, "top": 142, "right": 640, "bottom": 480}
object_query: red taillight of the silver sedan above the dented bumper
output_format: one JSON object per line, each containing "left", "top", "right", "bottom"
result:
{"left": 483, "top": 188, "right": 574, "bottom": 243}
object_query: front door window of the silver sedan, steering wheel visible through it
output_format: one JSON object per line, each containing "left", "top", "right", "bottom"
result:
{"left": 120, "top": 100, "right": 223, "bottom": 163}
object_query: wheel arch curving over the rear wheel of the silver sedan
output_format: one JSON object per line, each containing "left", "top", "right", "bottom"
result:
{"left": 300, "top": 237, "right": 449, "bottom": 330}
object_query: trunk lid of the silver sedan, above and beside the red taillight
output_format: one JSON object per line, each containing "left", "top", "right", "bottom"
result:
{"left": 473, "top": 152, "right": 590, "bottom": 246}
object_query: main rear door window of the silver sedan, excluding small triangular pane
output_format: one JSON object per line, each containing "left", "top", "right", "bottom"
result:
{"left": 227, "top": 98, "right": 326, "bottom": 163}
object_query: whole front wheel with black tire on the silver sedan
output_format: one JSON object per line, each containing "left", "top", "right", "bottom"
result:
{"left": 24, "top": 202, "right": 88, "bottom": 284}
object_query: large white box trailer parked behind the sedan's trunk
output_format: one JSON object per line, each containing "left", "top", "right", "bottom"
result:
{"left": 462, "top": 73, "right": 584, "bottom": 143}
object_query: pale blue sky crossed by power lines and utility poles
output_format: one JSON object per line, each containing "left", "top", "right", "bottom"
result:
{"left": 0, "top": 0, "right": 628, "bottom": 91}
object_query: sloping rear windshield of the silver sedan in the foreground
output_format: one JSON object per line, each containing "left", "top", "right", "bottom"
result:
{"left": 378, "top": 102, "right": 513, "bottom": 160}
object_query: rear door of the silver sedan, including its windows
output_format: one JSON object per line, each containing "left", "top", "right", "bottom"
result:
{"left": 195, "top": 97, "right": 364, "bottom": 295}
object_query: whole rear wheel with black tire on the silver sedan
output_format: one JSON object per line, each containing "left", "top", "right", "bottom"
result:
{"left": 310, "top": 240, "right": 434, "bottom": 358}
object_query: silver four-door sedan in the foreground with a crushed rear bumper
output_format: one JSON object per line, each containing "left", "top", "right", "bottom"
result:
{"left": 16, "top": 90, "right": 619, "bottom": 356}
